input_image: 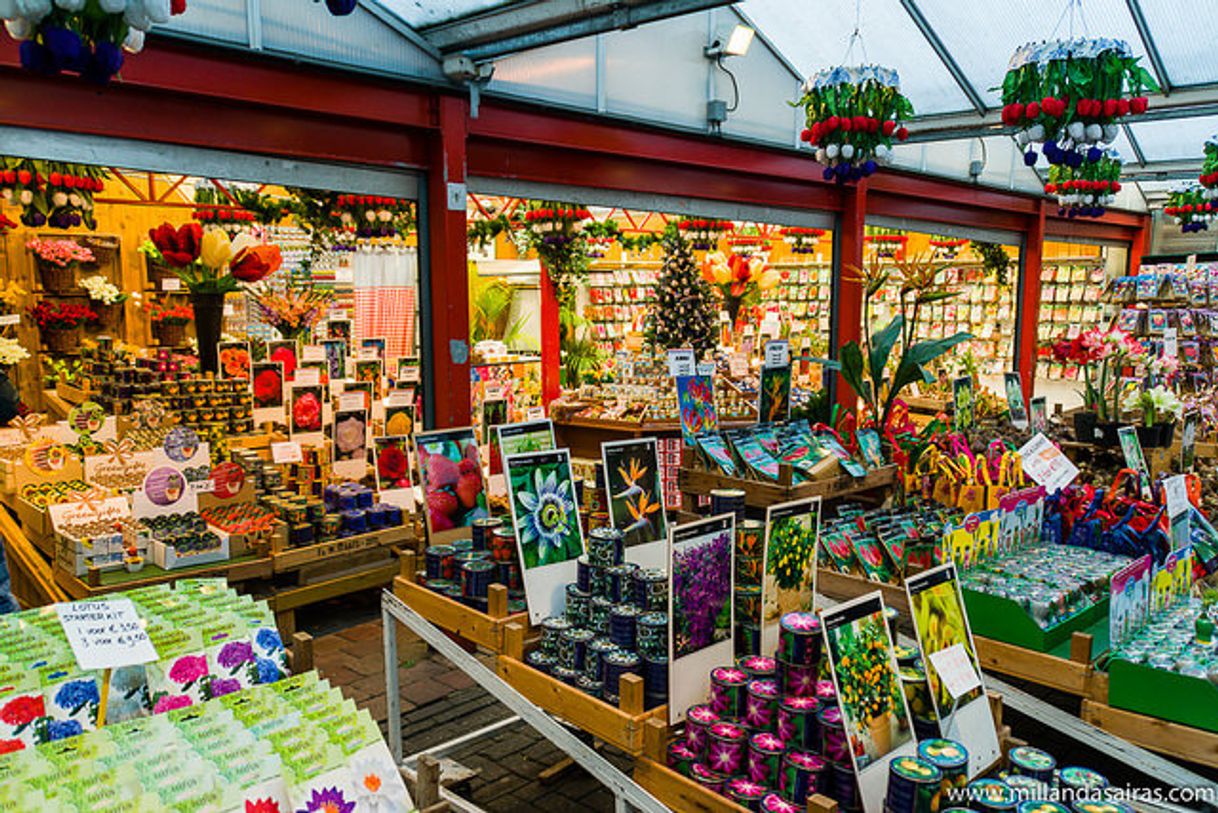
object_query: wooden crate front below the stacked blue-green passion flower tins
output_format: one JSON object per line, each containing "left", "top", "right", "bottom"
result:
{"left": 496, "top": 624, "right": 669, "bottom": 754}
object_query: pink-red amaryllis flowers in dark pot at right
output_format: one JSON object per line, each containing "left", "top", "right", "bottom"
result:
{"left": 1054, "top": 328, "right": 1145, "bottom": 446}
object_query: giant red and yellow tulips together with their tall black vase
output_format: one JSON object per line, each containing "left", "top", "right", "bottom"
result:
{"left": 149, "top": 223, "right": 283, "bottom": 373}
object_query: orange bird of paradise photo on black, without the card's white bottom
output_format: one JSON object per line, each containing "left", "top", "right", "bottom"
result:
{"left": 600, "top": 438, "right": 667, "bottom": 547}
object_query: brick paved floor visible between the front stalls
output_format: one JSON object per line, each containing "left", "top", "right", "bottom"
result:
{"left": 314, "top": 619, "right": 630, "bottom": 813}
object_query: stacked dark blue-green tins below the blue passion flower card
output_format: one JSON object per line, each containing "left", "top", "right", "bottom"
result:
{"left": 526, "top": 527, "right": 669, "bottom": 708}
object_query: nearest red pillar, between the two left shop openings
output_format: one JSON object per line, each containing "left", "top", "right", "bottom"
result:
{"left": 428, "top": 95, "right": 470, "bottom": 428}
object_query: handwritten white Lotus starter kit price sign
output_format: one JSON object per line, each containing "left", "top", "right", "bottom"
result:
{"left": 55, "top": 598, "right": 157, "bottom": 669}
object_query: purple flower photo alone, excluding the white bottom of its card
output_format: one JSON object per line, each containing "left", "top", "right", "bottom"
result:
{"left": 672, "top": 531, "right": 732, "bottom": 658}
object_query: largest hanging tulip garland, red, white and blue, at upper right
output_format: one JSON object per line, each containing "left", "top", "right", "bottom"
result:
{"left": 1002, "top": 39, "right": 1158, "bottom": 168}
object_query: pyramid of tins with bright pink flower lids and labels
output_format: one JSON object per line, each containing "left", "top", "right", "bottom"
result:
{"left": 669, "top": 613, "right": 859, "bottom": 813}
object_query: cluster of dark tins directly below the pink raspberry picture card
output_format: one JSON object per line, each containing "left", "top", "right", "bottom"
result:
{"left": 423, "top": 517, "right": 526, "bottom": 613}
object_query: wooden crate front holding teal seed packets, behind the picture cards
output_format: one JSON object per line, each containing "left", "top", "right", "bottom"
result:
{"left": 677, "top": 457, "right": 896, "bottom": 511}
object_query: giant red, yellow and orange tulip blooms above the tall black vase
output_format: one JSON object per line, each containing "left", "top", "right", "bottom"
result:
{"left": 149, "top": 223, "right": 283, "bottom": 294}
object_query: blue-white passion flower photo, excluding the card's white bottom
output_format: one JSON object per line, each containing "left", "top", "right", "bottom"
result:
{"left": 505, "top": 449, "right": 583, "bottom": 570}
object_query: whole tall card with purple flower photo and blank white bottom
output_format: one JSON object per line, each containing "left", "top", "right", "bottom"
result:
{"left": 667, "top": 514, "right": 736, "bottom": 724}
